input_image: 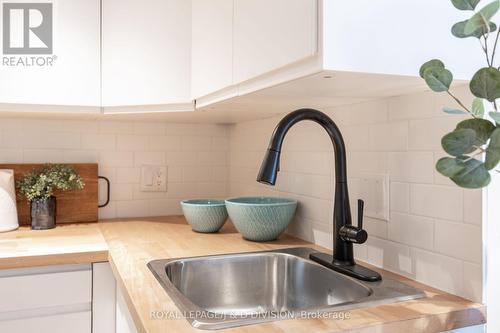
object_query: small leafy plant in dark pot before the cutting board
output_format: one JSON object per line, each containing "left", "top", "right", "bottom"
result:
{"left": 17, "top": 164, "right": 85, "bottom": 230}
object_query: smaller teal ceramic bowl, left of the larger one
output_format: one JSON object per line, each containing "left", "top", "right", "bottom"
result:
{"left": 181, "top": 199, "right": 227, "bottom": 233}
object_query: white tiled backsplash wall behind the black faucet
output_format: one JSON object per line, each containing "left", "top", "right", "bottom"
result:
{"left": 229, "top": 85, "right": 482, "bottom": 301}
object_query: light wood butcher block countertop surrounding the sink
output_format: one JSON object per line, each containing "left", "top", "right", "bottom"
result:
{"left": 0, "top": 217, "right": 486, "bottom": 333}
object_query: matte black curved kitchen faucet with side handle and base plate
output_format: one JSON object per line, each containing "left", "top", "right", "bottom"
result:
{"left": 257, "top": 109, "right": 381, "bottom": 281}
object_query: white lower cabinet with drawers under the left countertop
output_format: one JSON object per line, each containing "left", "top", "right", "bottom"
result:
{"left": 0, "top": 263, "right": 116, "bottom": 333}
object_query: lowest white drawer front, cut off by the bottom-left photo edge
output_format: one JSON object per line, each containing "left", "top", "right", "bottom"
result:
{"left": 0, "top": 311, "right": 92, "bottom": 333}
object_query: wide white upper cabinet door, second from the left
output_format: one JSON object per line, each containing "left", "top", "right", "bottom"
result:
{"left": 102, "top": 0, "right": 191, "bottom": 110}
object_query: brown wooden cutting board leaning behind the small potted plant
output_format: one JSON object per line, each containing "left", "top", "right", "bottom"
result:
{"left": 0, "top": 164, "right": 99, "bottom": 225}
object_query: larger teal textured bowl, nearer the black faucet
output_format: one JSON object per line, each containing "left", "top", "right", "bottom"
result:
{"left": 226, "top": 197, "right": 297, "bottom": 242}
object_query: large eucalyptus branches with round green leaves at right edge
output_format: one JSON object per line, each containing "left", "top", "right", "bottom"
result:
{"left": 420, "top": 0, "right": 500, "bottom": 188}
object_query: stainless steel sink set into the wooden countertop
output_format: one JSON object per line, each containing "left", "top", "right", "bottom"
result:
{"left": 148, "top": 248, "right": 424, "bottom": 329}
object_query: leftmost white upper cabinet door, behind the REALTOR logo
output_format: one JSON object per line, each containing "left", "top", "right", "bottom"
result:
{"left": 0, "top": 0, "right": 100, "bottom": 106}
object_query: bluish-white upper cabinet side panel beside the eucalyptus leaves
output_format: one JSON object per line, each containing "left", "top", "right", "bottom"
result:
{"left": 321, "top": 0, "right": 484, "bottom": 80}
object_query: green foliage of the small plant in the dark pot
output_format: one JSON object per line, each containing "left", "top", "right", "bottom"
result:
{"left": 17, "top": 164, "right": 85, "bottom": 202}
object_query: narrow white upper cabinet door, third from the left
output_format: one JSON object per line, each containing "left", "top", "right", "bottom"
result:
{"left": 191, "top": 0, "right": 233, "bottom": 99}
